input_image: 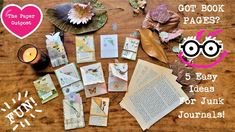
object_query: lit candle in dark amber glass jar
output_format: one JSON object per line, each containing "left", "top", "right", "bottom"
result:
{"left": 17, "top": 44, "right": 50, "bottom": 70}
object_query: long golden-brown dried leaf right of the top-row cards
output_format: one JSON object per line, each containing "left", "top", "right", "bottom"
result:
{"left": 139, "top": 29, "right": 168, "bottom": 63}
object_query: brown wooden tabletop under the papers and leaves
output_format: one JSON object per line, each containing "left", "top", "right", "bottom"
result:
{"left": 0, "top": 0, "right": 235, "bottom": 132}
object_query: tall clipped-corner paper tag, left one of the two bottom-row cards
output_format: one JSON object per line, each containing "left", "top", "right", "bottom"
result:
{"left": 63, "top": 94, "right": 85, "bottom": 130}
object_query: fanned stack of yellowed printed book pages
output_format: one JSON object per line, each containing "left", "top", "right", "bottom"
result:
{"left": 120, "top": 60, "right": 188, "bottom": 130}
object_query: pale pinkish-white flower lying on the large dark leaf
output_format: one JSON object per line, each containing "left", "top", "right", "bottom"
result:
{"left": 68, "top": 3, "right": 95, "bottom": 25}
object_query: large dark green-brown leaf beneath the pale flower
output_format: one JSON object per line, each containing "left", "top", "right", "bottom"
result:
{"left": 45, "top": 0, "right": 108, "bottom": 34}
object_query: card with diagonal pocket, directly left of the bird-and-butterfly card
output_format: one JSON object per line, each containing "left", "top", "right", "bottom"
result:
{"left": 55, "top": 63, "right": 83, "bottom": 95}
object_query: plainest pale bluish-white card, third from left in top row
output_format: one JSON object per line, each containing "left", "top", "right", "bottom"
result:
{"left": 100, "top": 34, "right": 118, "bottom": 58}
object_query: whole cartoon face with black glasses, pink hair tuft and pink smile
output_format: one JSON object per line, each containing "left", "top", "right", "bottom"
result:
{"left": 178, "top": 29, "right": 228, "bottom": 68}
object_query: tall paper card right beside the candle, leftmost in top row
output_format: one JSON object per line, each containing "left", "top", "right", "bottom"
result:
{"left": 46, "top": 32, "right": 68, "bottom": 67}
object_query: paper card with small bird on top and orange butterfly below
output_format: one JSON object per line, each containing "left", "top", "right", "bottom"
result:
{"left": 80, "top": 63, "right": 107, "bottom": 98}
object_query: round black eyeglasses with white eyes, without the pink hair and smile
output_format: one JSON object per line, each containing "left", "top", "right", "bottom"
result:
{"left": 180, "top": 37, "right": 223, "bottom": 59}
